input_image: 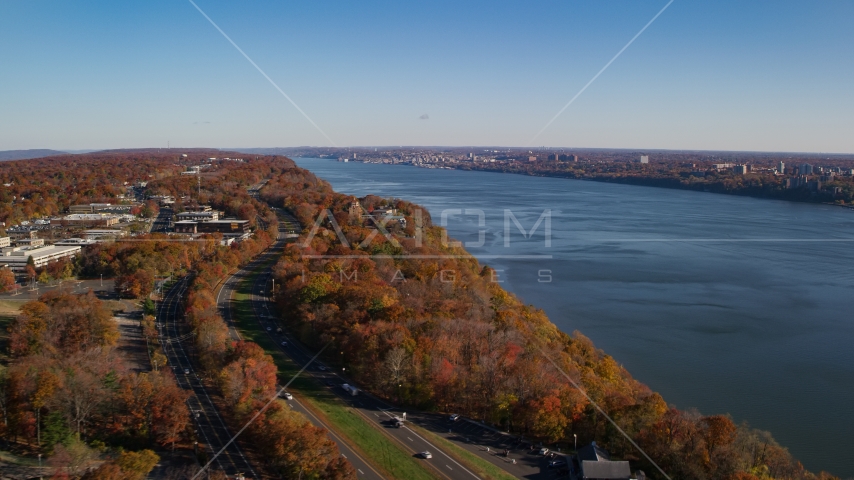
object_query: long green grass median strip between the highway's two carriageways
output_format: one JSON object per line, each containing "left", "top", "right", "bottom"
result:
{"left": 232, "top": 264, "right": 436, "bottom": 480}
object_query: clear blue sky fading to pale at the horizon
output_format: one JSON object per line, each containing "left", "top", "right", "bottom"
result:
{"left": 0, "top": 0, "right": 854, "bottom": 152}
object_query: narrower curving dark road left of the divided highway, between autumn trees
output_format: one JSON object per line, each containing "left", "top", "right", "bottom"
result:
{"left": 157, "top": 277, "right": 261, "bottom": 478}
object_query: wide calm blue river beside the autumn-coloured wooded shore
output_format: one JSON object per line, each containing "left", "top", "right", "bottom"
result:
{"left": 297, "top": 159, "right": 854, "bottom": 477}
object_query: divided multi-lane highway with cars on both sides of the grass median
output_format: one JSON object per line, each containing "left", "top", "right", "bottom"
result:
{"left": 218, "top": 216, "right": 488, "bottom": 480}
